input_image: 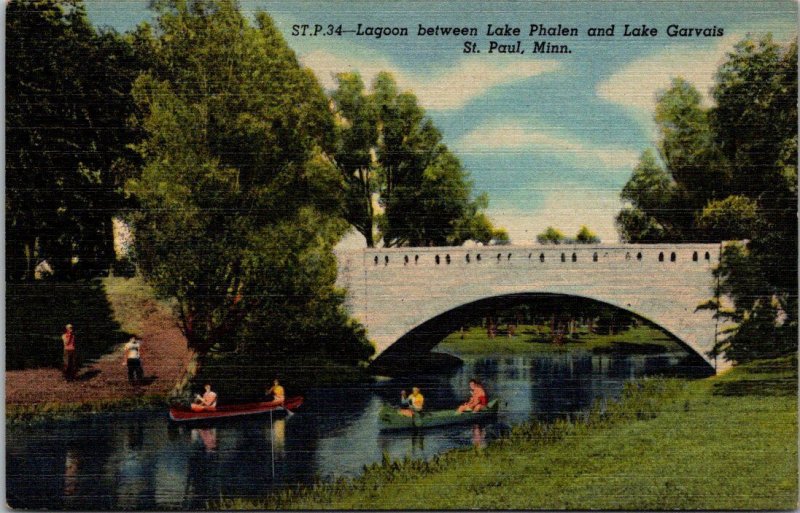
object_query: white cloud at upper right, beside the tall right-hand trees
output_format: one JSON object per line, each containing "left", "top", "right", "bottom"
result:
{"left": 596, "top": 34, "right": 742, "bottom": 116}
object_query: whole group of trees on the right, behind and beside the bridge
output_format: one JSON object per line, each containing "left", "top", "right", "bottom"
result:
{"left": 617, "top": 36, "right": 798, "bottom": 361}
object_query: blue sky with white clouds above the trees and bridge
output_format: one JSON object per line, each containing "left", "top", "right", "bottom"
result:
{"left": 86, "top": 0, "right": 797, "bottom": 247}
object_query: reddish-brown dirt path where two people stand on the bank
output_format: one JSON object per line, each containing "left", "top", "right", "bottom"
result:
{"left": 6, "top": 284, "right": 191, "bottom": 404}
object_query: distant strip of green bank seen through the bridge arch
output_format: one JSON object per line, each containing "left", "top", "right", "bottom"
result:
{"left": 436, "top": 325, "right": 682, "bottom": 358}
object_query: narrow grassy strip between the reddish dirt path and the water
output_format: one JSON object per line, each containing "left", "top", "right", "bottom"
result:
{"left": 6, "top": 394, "right": 167, "bottom": 426}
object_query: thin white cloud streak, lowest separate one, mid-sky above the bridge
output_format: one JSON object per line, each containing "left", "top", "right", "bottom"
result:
{"left": 455, "top": 123, "right": 639, "bottom": 171}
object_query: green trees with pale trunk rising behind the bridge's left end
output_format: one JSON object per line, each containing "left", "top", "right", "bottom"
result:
{"left": 332, "top": 73, "right": 508, "bottom": 247}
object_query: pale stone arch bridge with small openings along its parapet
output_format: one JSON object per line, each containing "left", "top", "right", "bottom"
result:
{"left": 337, "top": 243, "right": 723, "bottom": 370}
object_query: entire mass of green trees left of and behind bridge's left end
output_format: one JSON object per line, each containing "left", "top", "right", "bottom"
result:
{"left": 6, "top": 0, "right": 507, "bottom": 364}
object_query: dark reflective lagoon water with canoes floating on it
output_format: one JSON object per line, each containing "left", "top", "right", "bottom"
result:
{"left": 6, "top": 352, "right": 708, "bottom": 510}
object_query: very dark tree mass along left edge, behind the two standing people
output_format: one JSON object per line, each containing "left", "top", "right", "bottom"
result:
{"left": 6, "top": 0, "right": 142, "bottom": 280}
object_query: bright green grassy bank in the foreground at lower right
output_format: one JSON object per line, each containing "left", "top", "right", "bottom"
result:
{"left": 215, "top": 357, "right": 798, "bottom": 510}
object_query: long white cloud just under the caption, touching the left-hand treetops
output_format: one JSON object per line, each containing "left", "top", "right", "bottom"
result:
{"left": 300, "top": 50, "right": 560, "bottom": 110}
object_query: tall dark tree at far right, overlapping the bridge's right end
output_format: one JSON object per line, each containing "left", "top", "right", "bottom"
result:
{"left": 706, "top": 36, "right": 798, "bottom": 361}
